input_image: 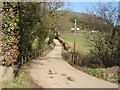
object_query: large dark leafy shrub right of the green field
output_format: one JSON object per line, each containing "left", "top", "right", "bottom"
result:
{"left": 90, "top": 33, "right": 120, "bottom": 67}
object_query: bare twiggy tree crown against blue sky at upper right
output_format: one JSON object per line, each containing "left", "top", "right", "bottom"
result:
{"left": 90, "top": 2, "right": 118, "bottom": 32}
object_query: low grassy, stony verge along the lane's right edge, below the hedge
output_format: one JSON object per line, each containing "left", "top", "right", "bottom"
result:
{"left": 74, "top": 65, "right": 119, "bottom": 84}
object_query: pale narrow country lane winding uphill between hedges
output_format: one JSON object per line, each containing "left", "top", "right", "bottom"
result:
{"left": 30, "top": 40, "right": 118, "bottom": 88}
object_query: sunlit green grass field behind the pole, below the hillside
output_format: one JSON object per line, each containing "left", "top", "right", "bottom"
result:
{"left": 62, "top": 32, "right": 92, "bottom": 55}
